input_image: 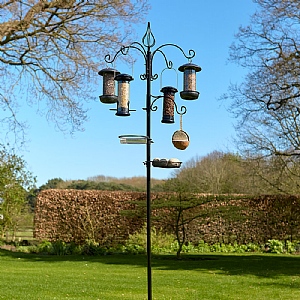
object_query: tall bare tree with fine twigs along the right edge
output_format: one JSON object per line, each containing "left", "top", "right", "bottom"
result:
{"left": 224, "top": 0, "right": 300, "bottom": 191}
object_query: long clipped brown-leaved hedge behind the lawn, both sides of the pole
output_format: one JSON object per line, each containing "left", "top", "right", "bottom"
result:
{"left": 35, "top": 190, "right": 300, "bottom": 245}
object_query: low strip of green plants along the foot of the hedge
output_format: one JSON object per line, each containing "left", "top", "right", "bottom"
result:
{"left": 12, "top": 237, "right": 300, "bottom": 258}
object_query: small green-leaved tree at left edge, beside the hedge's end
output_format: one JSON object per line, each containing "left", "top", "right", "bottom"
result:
{"left": 0, "top": 148, "right": 35, "bottom": 237}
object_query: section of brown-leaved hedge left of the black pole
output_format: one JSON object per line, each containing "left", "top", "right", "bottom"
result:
{"left": 35, "top": 190, "right": 146, "bottom": 245}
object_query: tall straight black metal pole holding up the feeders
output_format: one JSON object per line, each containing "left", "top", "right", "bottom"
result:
{"left": 146, "top": 42, "right": 152, "bottom": 300}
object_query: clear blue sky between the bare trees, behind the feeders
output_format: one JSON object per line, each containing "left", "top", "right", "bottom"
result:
{"left": 20, "top": 0, "right": 255, "bottom": 186}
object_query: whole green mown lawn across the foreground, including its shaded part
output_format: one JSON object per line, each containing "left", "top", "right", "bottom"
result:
{"left": 0, "top": 250, "right": 300, "bottom": 300}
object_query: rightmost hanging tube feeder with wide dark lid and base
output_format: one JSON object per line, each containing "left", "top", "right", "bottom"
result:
{"left": 178, "top": 63, "right": 201, "bottom": 100}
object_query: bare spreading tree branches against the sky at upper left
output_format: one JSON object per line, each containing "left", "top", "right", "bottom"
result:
{"left": 0, "top": 0, "right": 148, "bottom": 138}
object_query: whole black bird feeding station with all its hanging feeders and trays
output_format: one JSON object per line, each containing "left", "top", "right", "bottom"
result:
{"left": 99, "top": 23, "right": 201, "bottom": 300}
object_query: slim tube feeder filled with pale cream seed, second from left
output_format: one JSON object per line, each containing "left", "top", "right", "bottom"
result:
{"left": 115, "top": 74, "right": 133, "bottom": 116}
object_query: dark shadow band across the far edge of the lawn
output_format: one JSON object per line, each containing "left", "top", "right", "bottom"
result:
{"left": 0, "top": 249, "right": 300, "bottom": 280}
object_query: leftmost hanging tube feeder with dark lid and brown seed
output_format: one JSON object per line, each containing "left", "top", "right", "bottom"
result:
{"left": 98, "top": 68, "right": 120, "bottom": 104}
